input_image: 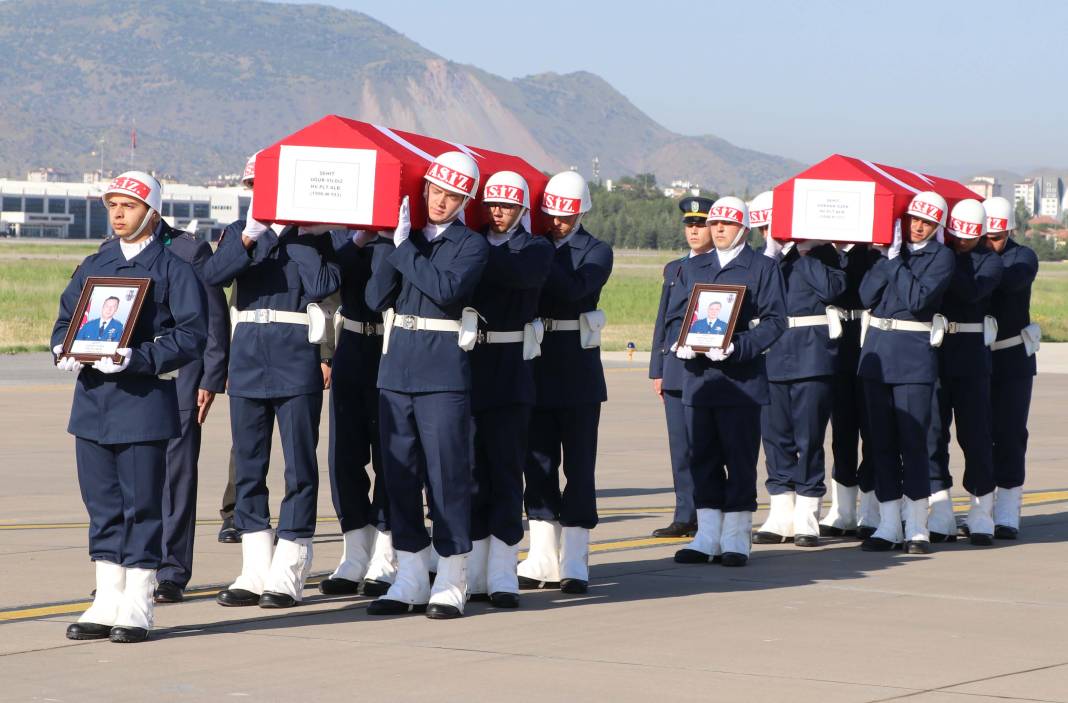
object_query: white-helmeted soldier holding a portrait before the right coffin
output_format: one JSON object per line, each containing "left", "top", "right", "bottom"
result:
{"left": 675, "top": 196, "right": 786, "bottom": 566}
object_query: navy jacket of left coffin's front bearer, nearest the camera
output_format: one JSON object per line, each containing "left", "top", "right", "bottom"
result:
{"left": 366, "top": 220, "right": 489, "bottom": 393}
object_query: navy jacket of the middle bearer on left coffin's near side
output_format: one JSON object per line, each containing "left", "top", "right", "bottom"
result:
{"left": 471, "top": 225, "right": 555, "bottom": 412}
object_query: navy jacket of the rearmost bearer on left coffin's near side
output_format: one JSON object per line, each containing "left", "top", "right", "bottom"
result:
{"left": 534, "top": 225, "right": 612, "bottom": 407}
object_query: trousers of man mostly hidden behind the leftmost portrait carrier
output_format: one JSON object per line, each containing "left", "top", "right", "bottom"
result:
{"left": 157, "top": 409, "right": 201, "bottom": 589}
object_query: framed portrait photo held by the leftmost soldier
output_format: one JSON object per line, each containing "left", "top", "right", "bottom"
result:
{"left": 60, "top": 276, "right": 152, "bottom": 363}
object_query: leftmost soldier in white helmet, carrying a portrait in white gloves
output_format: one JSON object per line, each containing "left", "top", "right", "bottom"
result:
{"left": 52, "top": 171, "right": 207, "bottom": 642}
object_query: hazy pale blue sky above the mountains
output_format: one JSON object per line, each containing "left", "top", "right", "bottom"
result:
{"left": 277, "top": 0, "right": 1068, "bottom": 175}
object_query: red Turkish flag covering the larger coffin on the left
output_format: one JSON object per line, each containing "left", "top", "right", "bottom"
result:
{"left": 253, "top": 114, "right": 548, "bottom": 230}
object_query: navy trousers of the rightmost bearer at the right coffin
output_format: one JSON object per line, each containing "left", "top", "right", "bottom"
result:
{"left": 990, "top": 376, "right": 1035, "bottom": 488}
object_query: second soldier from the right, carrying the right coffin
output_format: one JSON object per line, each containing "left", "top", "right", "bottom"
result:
{"left": 927, "top": 200, "right": 1002, "bottom": 546}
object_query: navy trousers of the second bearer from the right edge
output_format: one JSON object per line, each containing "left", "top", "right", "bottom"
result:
{"left": 927, "top": 376, "right": 994, "bottom": 496}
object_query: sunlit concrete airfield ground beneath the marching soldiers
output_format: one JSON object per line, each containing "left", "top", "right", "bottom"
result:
{"left": 0, "top": 345, "right": 1068, "bottom": 703}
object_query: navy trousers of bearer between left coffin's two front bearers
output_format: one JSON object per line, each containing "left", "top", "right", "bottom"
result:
{"left": 330, "top": 376, "right": 390, "bottom": 532}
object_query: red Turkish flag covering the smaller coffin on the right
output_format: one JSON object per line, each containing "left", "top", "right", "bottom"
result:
{"left": 771, "top": 154, "right": 983, "bottom": 245}
